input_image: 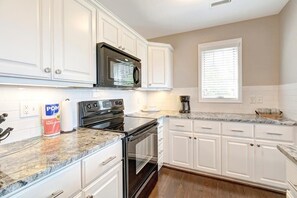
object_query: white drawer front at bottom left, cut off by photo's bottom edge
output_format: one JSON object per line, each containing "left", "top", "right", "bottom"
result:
{"left": 13, "top": 163, "right": 81, "bottom": 198}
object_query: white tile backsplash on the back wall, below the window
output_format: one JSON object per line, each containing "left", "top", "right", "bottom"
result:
{"left": 147, "top": 86, "right": 278, "bottom": 113}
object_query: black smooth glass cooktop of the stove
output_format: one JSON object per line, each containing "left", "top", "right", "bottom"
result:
{"left": 88, "top": 116, "right": 157, "bottom": 135}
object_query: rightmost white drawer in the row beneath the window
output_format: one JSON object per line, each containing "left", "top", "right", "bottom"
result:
{"left": 255, "top": 125, "right": 294, "bottom": 142}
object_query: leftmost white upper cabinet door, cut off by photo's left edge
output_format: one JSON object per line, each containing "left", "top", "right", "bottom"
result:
{"left": 0, "top": 0, "right": 51, "bottom": 79}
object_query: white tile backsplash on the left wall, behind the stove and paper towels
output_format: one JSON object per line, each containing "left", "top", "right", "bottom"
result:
{"left": 0, "top": 86, "right": 147, "bottom": 144}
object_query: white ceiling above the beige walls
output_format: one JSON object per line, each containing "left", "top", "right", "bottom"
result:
{"left": 97, "top": 0, "right": 289, "bottom": 39}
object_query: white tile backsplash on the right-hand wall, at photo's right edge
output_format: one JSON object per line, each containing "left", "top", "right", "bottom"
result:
{"left": 279, "top": 83, "right": 297, "bottom": 120}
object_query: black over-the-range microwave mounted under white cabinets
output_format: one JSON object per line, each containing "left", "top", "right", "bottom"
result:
{"left": 94, "top": 43, "right": 141, "bottom": 89}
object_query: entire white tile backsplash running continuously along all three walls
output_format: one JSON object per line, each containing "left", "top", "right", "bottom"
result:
{"left": 0, "top": 84, "right": 290, "bottom": 144}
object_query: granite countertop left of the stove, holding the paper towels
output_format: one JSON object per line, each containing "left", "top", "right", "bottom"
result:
{"left": 0, "top": 128, "right": 124, "bottom": 197}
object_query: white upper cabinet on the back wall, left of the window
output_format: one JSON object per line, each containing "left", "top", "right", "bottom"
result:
{"left": 148, "top": 42, "right": 173, "bottom": 89}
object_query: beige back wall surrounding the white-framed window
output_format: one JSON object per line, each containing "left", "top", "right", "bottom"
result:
{"left": 150, "top": 15, "right": 278, "bottom": 88}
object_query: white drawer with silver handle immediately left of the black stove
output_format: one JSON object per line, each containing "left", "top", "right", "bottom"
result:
{"left": 82, "top": 141, "right": 122, "bottom": 187}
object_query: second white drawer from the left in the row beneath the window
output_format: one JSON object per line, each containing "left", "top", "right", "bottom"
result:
{"left": 194, "top": 120, "right": 221, "bottom": 134}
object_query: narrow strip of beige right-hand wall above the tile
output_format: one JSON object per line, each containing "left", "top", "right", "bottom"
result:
{"left": 280, "top": 0, "right": 297, "bottom": 84}
